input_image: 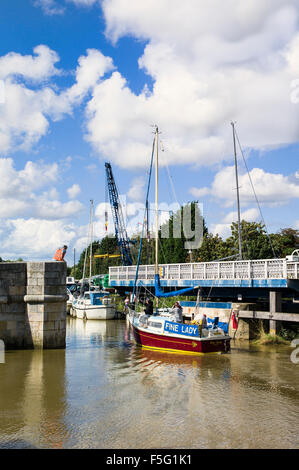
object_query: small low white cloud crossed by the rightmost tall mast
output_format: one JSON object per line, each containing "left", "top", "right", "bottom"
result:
{"left": 190, "top": 166, "right": 299, "bottom": 206}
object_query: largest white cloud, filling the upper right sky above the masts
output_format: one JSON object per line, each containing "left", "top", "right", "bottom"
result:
{"left": 78, "top": 0, "right": 299, "bottom": 167}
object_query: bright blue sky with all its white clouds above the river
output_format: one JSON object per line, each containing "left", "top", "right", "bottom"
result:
{"left": 0, "top": 0, "right": 299, "bottom": 264}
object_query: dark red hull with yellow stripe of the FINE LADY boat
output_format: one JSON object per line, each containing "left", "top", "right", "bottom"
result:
{"left": 131, "top": 323, "right": 230, "bottom": 356}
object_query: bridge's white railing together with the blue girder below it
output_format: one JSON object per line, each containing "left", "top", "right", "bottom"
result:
{"left": 109, "top": 259, "right": 299, "bottom": 290}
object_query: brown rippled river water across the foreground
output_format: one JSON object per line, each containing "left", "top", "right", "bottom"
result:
{"left": 0, "top": 318, "right": 299, "bottom": 449}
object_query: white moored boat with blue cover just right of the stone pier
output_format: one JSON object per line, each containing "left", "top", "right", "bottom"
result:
{"left": 71, "top": 291, "right": 116, "bottom": 320}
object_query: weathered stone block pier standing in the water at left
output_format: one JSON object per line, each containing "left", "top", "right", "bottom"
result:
{"left": 0, "top": 261, "right": 67, "bottom": 349}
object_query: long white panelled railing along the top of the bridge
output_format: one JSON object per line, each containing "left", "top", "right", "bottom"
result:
{"left": 109, "top": 259, "right": 299, "bottom": 282}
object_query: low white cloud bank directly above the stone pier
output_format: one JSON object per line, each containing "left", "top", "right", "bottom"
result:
{"left": 0, "top": 158, "right": 87, "bottom": 260}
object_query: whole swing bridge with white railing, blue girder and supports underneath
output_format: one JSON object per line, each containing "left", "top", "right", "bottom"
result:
{"left": 109, "top": 258, "right": 299, "bottom": 332}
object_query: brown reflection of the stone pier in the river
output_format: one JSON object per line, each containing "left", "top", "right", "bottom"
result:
{"left": 0, "top": 350, "right": 67, "bottom": 448}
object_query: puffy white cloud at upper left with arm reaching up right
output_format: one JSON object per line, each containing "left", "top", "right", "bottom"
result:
{"left": 0, "top": 45, "right": 113, "bottom": 155}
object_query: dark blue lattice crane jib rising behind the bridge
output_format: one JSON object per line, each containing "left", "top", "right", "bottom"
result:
{"left": 105, "top": 162, "right": 133, "bottom": 266}
